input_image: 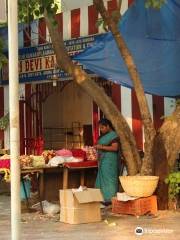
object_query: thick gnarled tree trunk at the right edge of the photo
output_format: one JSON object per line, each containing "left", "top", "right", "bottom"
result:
{"left": 153, "top": 105, "right": 180, "bottom": 209}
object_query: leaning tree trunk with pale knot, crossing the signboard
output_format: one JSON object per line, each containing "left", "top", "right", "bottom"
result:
{"left": 44, "top": 12, "right": 141, "bottom": 175}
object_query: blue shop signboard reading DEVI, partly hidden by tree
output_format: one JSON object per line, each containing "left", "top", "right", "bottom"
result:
{"left": 0, "top": 35, "right": 96, "bottom": 84}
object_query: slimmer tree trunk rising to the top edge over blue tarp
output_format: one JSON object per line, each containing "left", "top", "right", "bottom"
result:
{"left": 93, "top": 0, "right": 155, "bottom": 175}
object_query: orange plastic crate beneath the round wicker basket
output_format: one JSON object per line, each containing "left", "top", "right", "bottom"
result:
{"left": 112, "top": 195, "right": 157, "bottom": 216}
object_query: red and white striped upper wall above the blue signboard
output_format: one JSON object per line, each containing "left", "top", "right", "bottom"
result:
{"left": 19, "top": 0, "right": 129, "bottom": 48}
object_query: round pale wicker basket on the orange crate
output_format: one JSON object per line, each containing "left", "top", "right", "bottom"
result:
{"left": 119, "top": 176, "right": 159, "bottom": 197}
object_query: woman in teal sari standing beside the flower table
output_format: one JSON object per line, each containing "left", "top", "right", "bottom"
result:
{"left": 95, "top": 118, "right": 119, "bottom": 202}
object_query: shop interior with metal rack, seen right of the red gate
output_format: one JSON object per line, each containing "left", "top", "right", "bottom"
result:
{"left": 42, "top": 81, "right": 92, "bottom": 150}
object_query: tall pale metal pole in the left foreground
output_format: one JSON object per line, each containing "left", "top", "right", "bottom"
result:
{"left": 8, "top": 0, "right": 21, "bottom": 240}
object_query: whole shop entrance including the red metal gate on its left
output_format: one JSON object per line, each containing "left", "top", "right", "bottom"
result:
{"left": 20, "top": 78, "right": 111, "bottom": 154}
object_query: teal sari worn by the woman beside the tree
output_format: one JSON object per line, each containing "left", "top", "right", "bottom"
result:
{"left": 95, "top": 131, "right": 118, "bottom": 201}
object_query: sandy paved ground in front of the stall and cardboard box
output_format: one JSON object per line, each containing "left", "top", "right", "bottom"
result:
{"left": 0, "top": 195, "right": 180, "bottom": 240}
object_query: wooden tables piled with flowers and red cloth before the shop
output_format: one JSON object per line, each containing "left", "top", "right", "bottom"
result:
{"left": 0, "top": 147, "right": 97, "bottom": 205}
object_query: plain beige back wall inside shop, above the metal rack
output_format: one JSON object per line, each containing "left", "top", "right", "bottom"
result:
{"left": 43, "top": 83, "right": 92, "bottom": 127}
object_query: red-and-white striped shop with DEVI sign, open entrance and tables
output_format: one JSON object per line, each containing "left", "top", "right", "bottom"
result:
{"left": 0, "top": 0, "right": 174, "bottom": 211}
